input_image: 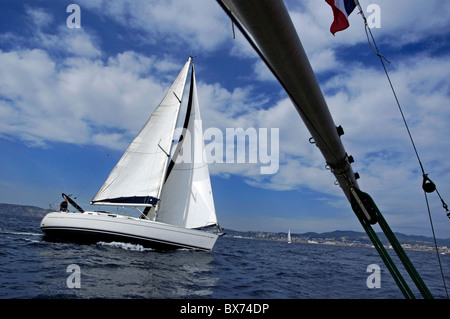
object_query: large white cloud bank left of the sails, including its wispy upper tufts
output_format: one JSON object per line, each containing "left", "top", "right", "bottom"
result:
{"left": 0, "top": 7, "right": 174, "bottom": 149}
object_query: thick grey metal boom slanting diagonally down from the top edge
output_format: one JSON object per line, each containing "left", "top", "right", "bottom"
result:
{"left": 223, "top": 0, "right": 357, "bottom": 204}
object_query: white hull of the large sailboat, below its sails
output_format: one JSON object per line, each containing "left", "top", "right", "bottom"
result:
{"left": 40, "top": 212, "right": 218, "bottom": 250}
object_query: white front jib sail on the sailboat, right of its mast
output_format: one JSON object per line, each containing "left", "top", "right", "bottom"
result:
{"left": 156, "top": 68, "right": 217, "bottom": 228}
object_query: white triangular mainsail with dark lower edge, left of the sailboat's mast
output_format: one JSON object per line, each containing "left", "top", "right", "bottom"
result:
{"left": 91, "top": 58, "right": 191, "bottom": 206}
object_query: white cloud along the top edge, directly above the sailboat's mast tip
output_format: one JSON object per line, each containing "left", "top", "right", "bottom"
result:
{"left": 80, "top": 0, "right": 231, "bottom": 55}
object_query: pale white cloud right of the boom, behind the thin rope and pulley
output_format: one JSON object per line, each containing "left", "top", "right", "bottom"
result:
{"left": 325, "top": 57, "right": 450, "bottom": 220}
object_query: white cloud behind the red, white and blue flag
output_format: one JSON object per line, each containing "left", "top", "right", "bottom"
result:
{"left": 285, "top": 0, "right": 450, "bottom": 72}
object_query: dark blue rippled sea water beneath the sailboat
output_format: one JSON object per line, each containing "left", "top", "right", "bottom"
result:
{"left": 0, "top": 214, "right": 450, "bottom": 299}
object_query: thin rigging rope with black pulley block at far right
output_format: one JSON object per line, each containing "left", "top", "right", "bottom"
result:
{"left": 355, "top": 0, "right": 450, "bottom": 298}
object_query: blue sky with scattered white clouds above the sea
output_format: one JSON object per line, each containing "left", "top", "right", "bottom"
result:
{"left": 0, "top": 0, "right": 450, "bottom": 238}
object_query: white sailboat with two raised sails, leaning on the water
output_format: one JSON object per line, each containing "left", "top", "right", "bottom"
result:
{"left": 40, "top": 57, "right": 220, "bottom": 250}
